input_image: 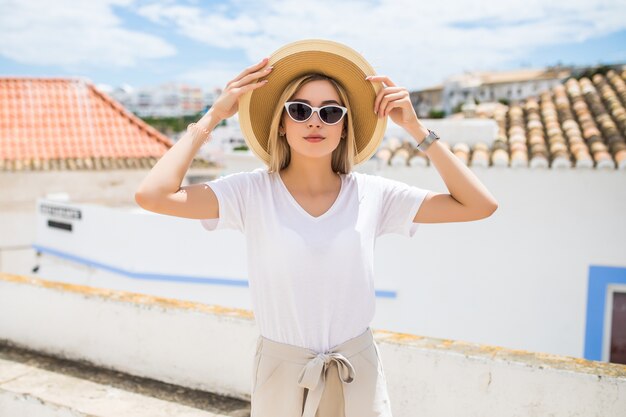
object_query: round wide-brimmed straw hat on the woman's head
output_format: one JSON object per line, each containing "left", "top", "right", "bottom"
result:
{"left": 238, "top": 39, "right": 387, "bottom": 165}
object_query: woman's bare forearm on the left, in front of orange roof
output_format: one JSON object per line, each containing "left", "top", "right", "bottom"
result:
{"left": 137, "top": 110, "right": 220, "bottom": 196}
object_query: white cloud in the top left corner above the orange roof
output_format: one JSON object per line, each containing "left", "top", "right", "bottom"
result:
{"left": 0, "top": 0, "right": 176, "bottom": 70}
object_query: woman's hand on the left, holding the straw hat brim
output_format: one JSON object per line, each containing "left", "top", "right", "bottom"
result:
{"left": 209, "top": 58, "right": 271, "bottom": 120}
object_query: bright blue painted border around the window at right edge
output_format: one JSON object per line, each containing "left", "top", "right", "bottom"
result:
{"left": 585, "top": 265, "right": 626, "bottom": 361}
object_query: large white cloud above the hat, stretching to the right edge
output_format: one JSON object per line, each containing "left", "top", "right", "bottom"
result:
{"left": 137, "top": 0, "right": 626, "bottom": 88}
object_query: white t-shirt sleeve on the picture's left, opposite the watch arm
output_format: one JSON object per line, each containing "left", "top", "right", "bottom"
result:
{"left": 200, "top": 172, "right": 254, "bottom": 233}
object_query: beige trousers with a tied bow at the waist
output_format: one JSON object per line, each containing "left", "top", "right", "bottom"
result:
{"left": 251, "top": 327, "right": 392, "bottom": 417}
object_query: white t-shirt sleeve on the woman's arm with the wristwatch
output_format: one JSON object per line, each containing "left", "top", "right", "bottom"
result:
{"left": 376, "top": 176, "right": 430, "bottom": 237}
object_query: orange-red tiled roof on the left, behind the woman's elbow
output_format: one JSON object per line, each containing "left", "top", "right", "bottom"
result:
{"left": 0, "top": 77, "right": 214, "bottom": 171}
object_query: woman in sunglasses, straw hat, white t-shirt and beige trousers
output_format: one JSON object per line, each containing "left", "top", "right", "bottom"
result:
{"left": 136, "top": 40, "right": 497, "bottom": 417}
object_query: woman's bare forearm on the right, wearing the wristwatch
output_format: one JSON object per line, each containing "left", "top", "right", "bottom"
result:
{"left": 409, "top": 124, "right": 498, "bottom": 210}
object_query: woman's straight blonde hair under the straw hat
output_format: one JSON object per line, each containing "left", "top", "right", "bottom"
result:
{"left": 268, "top": 73, "right": 356, "bottom": 174}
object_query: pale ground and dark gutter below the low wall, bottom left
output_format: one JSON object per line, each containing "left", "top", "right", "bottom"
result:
{"left": 0, "top": 340, "right": 250, "bottom": 417}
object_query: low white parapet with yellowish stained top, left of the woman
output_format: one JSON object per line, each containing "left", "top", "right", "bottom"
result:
{"left": 0, "top": 274, "right": 258, "bottom": 401}
